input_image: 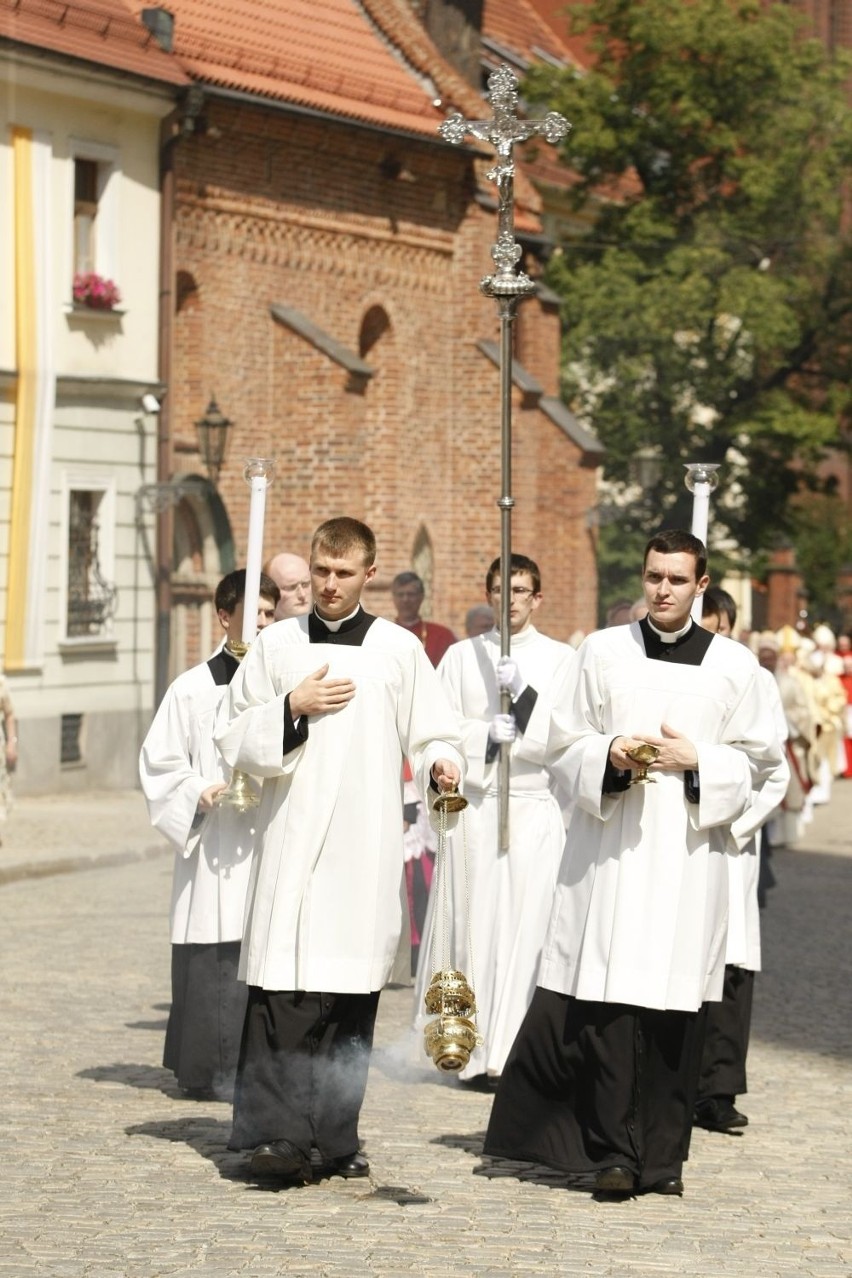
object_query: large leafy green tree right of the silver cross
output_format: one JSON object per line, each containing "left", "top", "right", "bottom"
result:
{"left": 525, "top": 0, "right": 852, "bottom": 618}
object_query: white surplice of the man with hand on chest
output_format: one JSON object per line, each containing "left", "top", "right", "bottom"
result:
{"left": 216, "top": 616, "right": 464, "bottom": 994}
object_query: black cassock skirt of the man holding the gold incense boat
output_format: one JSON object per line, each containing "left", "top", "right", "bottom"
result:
{"left": 485, "top": 987, "right": 704, "bottom": 1187}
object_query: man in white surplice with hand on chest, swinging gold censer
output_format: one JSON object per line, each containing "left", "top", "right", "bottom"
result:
{"left": 216, "top": 518, "right": 464, "bottom": 1181}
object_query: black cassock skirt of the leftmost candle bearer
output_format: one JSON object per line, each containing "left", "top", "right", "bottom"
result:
{"left": 162, "top": 941, "right": 247, "bottom": 1097}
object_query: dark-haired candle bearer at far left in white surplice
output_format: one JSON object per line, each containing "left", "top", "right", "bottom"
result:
{"left": 139, "top": 569, "right": 278, "bottom": 1098}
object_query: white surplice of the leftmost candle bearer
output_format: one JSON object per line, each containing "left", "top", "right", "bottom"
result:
{"left": 139, "top": 662, "right": 254, "bottom": 944}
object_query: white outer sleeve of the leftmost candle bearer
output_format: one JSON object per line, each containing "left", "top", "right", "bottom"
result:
{"left": 139, "top": 684, "right": 212, "bottom": 856}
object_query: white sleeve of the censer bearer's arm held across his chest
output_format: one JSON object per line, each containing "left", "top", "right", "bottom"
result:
{"left": 215, "top": 633, "right": 298, "bottom": 777}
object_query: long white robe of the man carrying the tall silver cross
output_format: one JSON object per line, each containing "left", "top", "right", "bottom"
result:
{"left": 414, "top": 626, "right": 576, "bottom": 1080}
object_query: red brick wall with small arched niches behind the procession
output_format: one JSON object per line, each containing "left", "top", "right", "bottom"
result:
{"left": 170, "top": 104, "right": 597, "bottom": 649}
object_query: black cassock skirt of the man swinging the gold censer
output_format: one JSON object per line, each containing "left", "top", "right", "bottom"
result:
{"left": 229, "top": 985, "right": 378, "bottom": 1159}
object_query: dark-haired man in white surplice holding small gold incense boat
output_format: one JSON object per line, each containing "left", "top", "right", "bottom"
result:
{"left": 485, "top": 530, "right": 782, "bottom": 1195}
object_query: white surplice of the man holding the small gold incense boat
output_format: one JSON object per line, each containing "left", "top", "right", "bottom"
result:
{"left": 538, "top": 622, "right": 782, "bottom": 1011}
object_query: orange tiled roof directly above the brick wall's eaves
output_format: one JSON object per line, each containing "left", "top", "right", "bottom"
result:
{"left": 144, "top": 0, "right": 445, "bottom": 137}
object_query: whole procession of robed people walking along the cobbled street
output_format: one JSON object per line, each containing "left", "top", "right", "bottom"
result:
{"left": 136, "top": 519, "right": 852, "bottom": 1195}
